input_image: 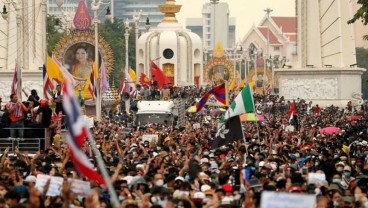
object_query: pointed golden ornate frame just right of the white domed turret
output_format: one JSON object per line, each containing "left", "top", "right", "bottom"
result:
{"left": 203, "top": 42, "right": 235, "bottom": 84}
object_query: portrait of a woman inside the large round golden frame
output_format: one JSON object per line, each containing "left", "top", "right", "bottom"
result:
{"left": 64, "top": 42, "right": 101, "bottom": 80}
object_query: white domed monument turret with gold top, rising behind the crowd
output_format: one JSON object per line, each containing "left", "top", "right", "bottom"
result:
{"left": 136, "top": 0, "right": 203, "bottom": 86}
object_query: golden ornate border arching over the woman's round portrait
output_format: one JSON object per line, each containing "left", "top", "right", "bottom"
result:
{"left": 52, "top": 31, "right": 115, "bottom": 76}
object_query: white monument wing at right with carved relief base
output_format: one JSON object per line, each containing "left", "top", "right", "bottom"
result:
{"left": 275, "top": 0, "right": 365, "bottom": 106}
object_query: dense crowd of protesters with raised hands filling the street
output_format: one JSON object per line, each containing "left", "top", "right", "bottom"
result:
{"left": 0, "top": 85, "right": 368, "bottom": 208}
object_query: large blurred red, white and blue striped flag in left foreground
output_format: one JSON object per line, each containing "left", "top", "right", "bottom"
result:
{"left": 63, "top": 83, "right": 106, "bottom": 184}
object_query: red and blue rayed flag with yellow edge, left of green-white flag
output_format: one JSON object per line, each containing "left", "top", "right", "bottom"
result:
{"left": 196, "top": 83, "right": 227, "bottom": 112}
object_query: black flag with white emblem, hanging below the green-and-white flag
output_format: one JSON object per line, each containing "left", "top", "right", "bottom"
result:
{"left": 212, "top": 116, "right": 243, "bottom": 149}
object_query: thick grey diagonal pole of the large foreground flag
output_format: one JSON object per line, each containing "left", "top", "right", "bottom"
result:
{"left": 87, "top": 131, "right": 120, "bottom": 207}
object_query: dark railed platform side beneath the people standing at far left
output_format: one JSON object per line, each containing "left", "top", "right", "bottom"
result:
{"left": 0, "top": 128, "right": 48, "bottom": 154}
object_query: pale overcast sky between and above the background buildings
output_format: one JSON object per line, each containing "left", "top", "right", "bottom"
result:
{"left": 176, "top": 0, "right": 295, "bottom": 41}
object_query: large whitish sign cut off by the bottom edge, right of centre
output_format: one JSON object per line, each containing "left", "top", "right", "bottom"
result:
{"left": 261, "top": 191, "right": 316, "bottom": 208}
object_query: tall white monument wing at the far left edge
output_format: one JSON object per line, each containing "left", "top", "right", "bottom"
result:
{"left": 0, "top": 0, "right": 47, "bottom": 98}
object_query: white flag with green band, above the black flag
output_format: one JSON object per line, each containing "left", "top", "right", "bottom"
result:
{"left": 223, "top": 84, "right": 255, "bottom": 120}
